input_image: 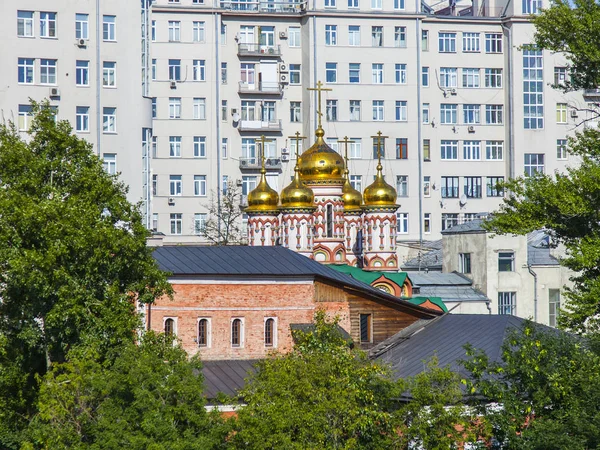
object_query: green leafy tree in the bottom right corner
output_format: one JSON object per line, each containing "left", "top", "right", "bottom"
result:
{"left": 465, "top": 323, "right": 600, "bottom": 450}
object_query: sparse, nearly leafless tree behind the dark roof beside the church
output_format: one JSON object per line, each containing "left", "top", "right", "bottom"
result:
{"left": 202, "top": 182, "right": 247, "bottom": 245}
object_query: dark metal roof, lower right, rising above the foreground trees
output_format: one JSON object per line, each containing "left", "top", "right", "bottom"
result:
{"left": 369, "top": 314, "right": 525, "bottom": 378}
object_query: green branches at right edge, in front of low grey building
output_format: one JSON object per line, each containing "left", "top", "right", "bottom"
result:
{"left": 485, "top": 129, "right": 600, "bottom": 332}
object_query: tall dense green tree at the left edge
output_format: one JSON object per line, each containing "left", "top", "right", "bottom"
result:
{"left": 0, "top": 103, "right": 171, "bottom": 448}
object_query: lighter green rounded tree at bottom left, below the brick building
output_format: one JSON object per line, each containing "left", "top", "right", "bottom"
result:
{"left": 28, "top": 332, "right": 224, "bottom": 450}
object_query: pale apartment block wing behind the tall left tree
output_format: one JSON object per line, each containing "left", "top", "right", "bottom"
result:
{"left": 0, "top": 0, "right": 152, "bottom": 224}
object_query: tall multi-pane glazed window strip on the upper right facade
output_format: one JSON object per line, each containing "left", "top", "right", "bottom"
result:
{"left": 523, "top": 47, "right": 544, "bottom": 130}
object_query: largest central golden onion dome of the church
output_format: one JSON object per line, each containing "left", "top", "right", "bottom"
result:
{"left": 299, "top": 126, "right": 345, "bottom": 183}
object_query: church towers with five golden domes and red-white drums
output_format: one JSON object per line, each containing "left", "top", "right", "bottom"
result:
{"left": 245, "top": 82, "right": 399, "bottom": 272}
